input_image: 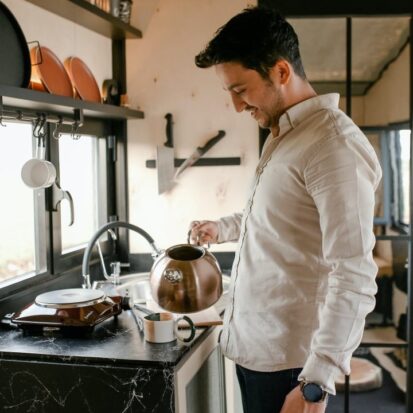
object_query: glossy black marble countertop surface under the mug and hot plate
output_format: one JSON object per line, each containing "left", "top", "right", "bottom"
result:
{"left": 0, "top": 310, "right": 213, "bottom": 368}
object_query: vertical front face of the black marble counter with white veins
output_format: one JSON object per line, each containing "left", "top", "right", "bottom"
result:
{"left": 0, "top": 361, "right": 174, "bottom": 413}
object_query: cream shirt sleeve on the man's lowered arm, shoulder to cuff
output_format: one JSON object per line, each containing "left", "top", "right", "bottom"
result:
{"left": 300, "top": 133, "right": 381, "bottom": 394}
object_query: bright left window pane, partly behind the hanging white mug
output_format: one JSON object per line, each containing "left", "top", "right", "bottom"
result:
{"left": 0, "top": 122, "right": 46, "bottom": 283}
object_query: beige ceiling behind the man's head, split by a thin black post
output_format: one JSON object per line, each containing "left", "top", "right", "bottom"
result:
{"left": 288, "top": 17, "right": 409, "bottom": 95}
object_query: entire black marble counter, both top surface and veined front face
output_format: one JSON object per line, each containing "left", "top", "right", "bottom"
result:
{"left": 0, "top": 311, "right": 206, "bottom": 413}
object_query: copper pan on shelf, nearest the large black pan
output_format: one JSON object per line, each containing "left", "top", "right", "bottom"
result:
{"left": 30, "top": 46, "right": 74, "bottom": 97}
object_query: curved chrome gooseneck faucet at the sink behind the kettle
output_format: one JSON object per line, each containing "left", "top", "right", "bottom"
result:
{"left": 82, "top": 221, "right": 163, "bottom": 288}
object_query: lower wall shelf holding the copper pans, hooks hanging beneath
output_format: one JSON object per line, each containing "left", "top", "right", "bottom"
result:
{"left": 0, "top": 85, "right": 144, "bottom": 119}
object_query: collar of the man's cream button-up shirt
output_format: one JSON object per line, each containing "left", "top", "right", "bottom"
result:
{"left": 279, "top": 93, "right": 340, "bottom": 136}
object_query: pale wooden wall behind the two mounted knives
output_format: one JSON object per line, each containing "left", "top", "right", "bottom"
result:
{"left": 127, "top": 0, "right": 258, "bottom": 252}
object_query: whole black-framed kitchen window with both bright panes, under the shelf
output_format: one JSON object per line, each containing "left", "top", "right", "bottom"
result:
{"left": 0, "top": 114, "right": 112, "bottom": 296}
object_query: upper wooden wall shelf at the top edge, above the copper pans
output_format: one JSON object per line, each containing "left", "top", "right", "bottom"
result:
{"left": 26, "top": 0, "right": 142, "bottom": 40}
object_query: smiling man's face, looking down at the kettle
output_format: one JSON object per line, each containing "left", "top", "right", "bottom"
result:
{"left": 215, "top": 62, "right": 285, "bottom": 129}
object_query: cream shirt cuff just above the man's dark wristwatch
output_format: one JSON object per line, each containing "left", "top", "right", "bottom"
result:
{"left": 298, "top": 353, "right": 341, "bottom": 395}
